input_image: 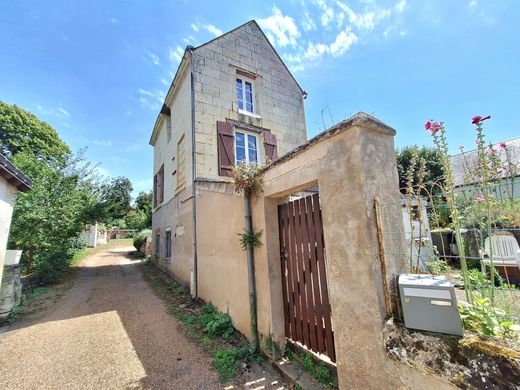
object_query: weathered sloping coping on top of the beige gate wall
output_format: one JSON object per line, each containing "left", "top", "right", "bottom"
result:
{"left": 266, "top": 112, "right": 396, "bottom": 169}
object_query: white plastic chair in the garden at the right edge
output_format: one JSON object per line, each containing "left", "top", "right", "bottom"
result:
{"left": 482, "top": 235, "right": 520, "bottom": 273}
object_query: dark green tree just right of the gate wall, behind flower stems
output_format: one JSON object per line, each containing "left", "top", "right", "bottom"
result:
{"left": 396, "top": 145, "right": 444, "bottom": 196}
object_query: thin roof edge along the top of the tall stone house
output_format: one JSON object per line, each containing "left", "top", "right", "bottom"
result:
{"left": 149, "top": 19, "right": 307, "bottom": 145}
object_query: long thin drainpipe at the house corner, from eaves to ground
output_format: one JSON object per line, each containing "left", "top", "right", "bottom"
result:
{"left": 186, "top": 46, "right": 197, "bottom": 298}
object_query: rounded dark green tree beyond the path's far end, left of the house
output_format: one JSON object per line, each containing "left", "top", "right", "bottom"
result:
{"left": 102, "top": 177, "right": 133, "bottom": 225}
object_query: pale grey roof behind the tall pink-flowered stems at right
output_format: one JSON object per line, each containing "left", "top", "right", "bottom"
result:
{"left": 450, "top": 138, "right": 520, "bottom": 187}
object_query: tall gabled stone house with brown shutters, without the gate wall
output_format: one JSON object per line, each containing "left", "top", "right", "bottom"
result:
{"left": 150, "top": 21, "right": 307, "bottom": 331}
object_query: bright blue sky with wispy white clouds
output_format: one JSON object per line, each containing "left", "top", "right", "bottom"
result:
{"left": 0, "top": 0, "right": 520, "bottom": 192}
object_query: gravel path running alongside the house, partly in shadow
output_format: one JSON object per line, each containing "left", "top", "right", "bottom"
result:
{"left": 0, "top": 248, "right": 222, "bottom": 389}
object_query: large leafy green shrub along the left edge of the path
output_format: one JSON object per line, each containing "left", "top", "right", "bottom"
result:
{"left": 8, "top": 153, "right": 96, "bottom": 283}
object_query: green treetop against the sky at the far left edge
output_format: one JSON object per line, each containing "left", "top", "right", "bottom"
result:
{"left": 0, "top": 101, "right": 70, "bottom": 162}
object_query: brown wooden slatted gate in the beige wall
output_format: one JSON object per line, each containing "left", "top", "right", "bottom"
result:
{"left": 278, "top": 194, "right": 336, "bottom": 362}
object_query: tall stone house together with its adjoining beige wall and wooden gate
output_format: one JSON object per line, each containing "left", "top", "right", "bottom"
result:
{"left": 150, "top": 21, "right": 451, "bottom": 389}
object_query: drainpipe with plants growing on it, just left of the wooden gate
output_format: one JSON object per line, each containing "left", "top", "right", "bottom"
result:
{"left": 244, "top": 193, "right": 259, "bottom": 352}
